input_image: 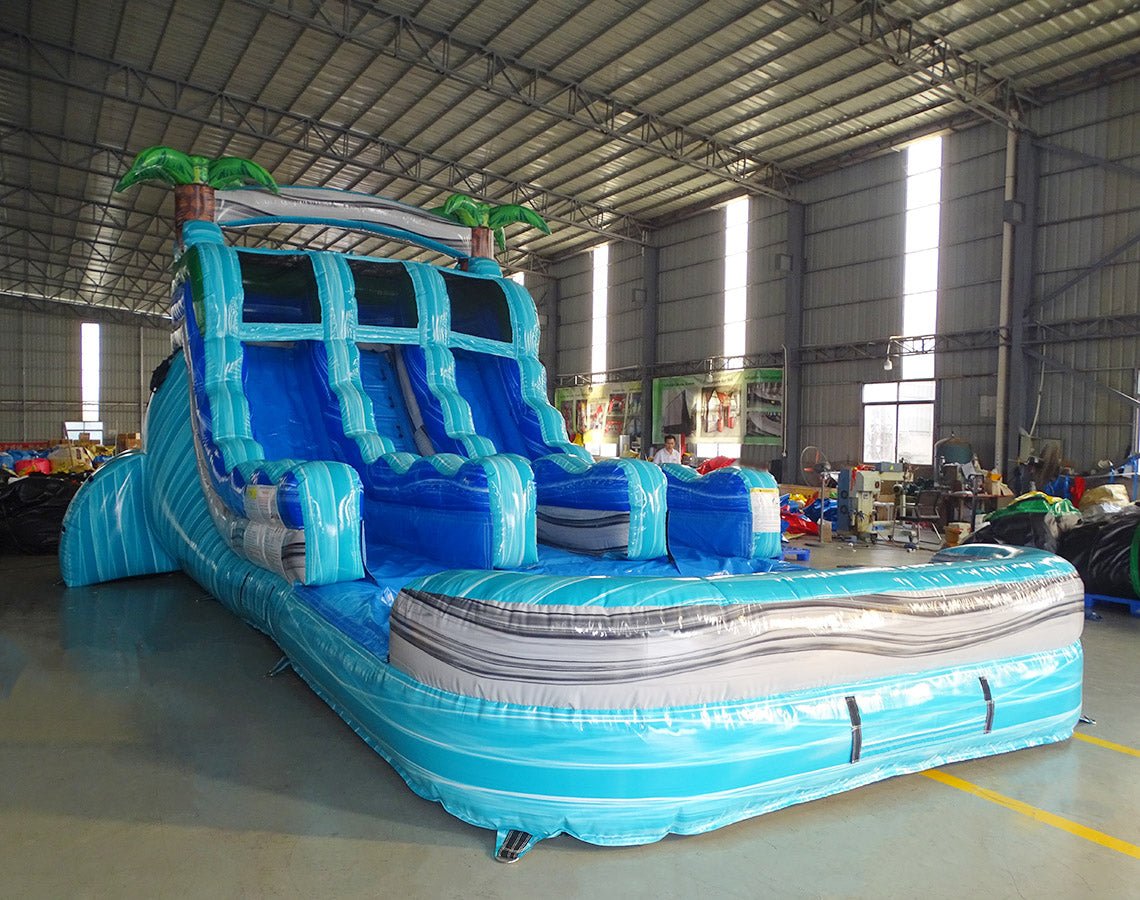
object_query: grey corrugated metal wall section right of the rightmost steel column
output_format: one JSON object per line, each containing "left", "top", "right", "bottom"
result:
{"left": 1029, "top": 76, "right": 1140, "bottom": 467}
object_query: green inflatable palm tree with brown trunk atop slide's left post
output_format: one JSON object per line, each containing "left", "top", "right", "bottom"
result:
{"left": 115, "top": 147, "right": 278, "bottom": 236}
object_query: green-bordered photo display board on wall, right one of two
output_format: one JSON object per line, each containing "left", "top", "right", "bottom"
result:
{"left": 653, "top": 368, "right": 783, "bottom": 445}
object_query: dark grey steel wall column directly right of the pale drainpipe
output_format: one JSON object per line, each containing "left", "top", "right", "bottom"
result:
{"left": 1012, "top": 140, "right": 1040, "bottom": 472}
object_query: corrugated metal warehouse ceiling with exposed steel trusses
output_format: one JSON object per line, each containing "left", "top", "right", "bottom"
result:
{"left": 0, "top": 0, "right": 1140, "bottom": 311}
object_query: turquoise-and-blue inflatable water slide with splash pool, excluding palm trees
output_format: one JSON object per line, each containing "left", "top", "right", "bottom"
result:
{"left": 60, "top": 163, "right": 1083, "bottom": 861}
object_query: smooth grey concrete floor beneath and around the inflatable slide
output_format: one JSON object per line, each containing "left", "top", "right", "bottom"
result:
{"left": 0, "top": 545, "right": 1140, "bottom": 900}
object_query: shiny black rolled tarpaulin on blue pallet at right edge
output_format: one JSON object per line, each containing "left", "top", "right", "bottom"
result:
{"left": 1058, "top": 505, "right": 1140, "bottom": 598}
